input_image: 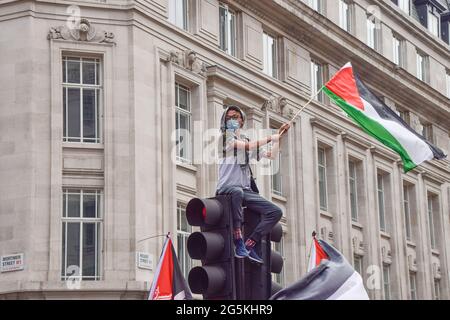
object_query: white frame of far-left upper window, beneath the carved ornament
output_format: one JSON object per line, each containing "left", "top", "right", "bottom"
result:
{"left": 62, "top": 54, "right": 103, "bottom": 144}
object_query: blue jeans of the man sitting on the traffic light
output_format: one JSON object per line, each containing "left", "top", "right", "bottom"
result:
{"left": 216, "top": 187, "right": 283, "bottom": 242}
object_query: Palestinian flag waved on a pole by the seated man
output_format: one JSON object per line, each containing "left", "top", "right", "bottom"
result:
{"left": 322, "top": 63, "right": 446, "bottom": 172}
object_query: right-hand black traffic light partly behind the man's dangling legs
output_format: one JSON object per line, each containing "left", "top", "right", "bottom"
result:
{"left": 244, "top": 209, "right": 283, "bottom": 300}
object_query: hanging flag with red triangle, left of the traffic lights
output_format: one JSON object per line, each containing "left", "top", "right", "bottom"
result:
{"left": 148, "top": 237, "right": 192, "bottom": 300}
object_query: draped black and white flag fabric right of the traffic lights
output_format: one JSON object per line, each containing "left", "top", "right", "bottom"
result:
{"left": 270, "top": 240, "right": 369, "bottom": 300}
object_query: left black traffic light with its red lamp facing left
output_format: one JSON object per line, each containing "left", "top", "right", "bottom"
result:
{"left": 186, "top": 196, "right": 236, "bottom": 300}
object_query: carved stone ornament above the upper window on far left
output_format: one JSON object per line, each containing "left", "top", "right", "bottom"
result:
{"left": 47, "top": 18, "right": 115, "bottom": 44}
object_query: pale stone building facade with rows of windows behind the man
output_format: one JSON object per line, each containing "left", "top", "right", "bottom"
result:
{"left": 0, "top": 0, "right": 450, "bottom": 299}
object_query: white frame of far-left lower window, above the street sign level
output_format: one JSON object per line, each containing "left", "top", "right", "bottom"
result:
{"left": 61, "top": 188, "right": 103, "bottom": 281}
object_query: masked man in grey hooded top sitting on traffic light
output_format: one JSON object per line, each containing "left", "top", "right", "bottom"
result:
{"left": 216, "top": 106, "right": 290, "bottom": 264}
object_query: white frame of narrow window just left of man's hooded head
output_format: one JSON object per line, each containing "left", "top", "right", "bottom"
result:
{"left": 175, "top": 82, "right": 193, "bottom": 164}
